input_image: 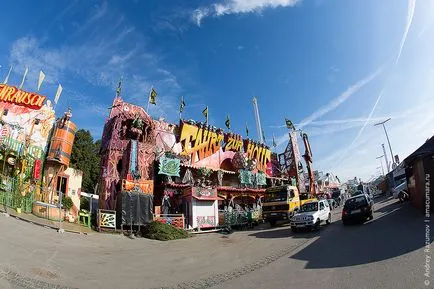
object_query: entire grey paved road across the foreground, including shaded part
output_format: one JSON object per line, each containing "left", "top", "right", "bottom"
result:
{"left": 0, "top": 196, "right": 434, "bottom": 289}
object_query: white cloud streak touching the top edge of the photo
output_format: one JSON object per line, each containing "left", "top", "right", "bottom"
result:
{"left": 192, "top": 0, "right": 301, "bottom": 26}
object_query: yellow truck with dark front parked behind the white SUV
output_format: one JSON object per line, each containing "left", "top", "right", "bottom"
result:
{"left": 262, "top": 186, "right": 313, "bottom": 226}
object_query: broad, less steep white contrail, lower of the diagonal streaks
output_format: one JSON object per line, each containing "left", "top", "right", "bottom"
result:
{"left": 298, "top": 67, "right": 383, "bottom": 129}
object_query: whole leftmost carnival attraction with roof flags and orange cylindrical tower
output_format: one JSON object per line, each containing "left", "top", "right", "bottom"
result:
{"left": 0, "top": 70, "right": 81, "bottom": 219}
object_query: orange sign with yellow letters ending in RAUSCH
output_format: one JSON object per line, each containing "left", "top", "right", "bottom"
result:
{"left": 0, "top": 84, "right": 47, "bottom": 109}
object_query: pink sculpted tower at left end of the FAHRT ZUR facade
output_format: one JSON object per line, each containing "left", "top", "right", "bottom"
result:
{"left": 100, "top": 97, "right": 156, "bottom": 210}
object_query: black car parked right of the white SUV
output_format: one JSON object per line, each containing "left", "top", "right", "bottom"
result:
{"left": 342, "top": 194, "right": 374, "bottom": 225}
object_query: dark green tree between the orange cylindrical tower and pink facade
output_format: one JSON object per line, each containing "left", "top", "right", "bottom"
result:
{"left": 71, "top": 129, "right": 101, "bottom": 193}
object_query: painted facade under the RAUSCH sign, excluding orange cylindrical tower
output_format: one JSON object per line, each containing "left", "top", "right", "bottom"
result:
{"left": 0, "top": 84, "right": 55, "bottom": 211}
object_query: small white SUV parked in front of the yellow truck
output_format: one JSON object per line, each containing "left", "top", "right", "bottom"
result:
{"left": 290, "top": 200, "right": 332, "bottom": 232}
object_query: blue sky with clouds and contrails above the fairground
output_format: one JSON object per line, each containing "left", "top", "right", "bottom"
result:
{"left": 0, "top": 0, "right": 434, "bottom": 179}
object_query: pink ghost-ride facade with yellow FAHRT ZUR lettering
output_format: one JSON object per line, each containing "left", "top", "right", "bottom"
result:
{"left": 100, "top": 96, "right": 285, "bottom": 229}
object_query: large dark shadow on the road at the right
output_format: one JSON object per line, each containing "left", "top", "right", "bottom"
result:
{"left": 290, "top": 203, "right": 425, "bottom": 269}
